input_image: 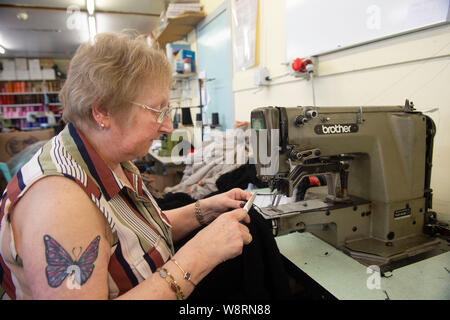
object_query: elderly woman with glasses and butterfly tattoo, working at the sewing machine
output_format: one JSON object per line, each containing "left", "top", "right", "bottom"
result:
{"left": 0, "top": 33, "right": 252, "bottom": 299}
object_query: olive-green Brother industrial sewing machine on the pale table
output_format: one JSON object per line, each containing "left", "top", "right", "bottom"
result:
{"left": 251, "top": 101, "right": 439, "bottom": 265}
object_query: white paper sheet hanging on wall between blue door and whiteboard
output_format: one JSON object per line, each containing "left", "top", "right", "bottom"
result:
{"left": 231, "top": 0, "right": 258, "bottom": 71}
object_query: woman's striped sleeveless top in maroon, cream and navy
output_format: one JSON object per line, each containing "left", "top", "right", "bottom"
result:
{"left": 0, "top": 123, "right": 174, "bottom": 299}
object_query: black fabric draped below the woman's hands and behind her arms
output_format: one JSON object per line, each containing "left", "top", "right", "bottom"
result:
{"left": 156, "top": 193, "right": 291, "bottom": 301}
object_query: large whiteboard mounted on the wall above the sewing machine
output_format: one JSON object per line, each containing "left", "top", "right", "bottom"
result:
{"left": 285, "top": 0, "right": 450, "bottom": 61}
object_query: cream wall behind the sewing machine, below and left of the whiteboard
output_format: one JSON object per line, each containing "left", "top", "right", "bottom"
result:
{"left": 202, "top": 0, "right": 450, "bottom": 219}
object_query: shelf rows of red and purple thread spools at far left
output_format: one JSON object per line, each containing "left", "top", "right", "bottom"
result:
{"left": 0, "top": 80, "right": 62, "bottom": 130}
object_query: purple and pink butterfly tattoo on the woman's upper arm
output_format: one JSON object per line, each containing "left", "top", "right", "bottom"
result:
{"left": 44, "top": 234, "right": 100, "bottom": 289}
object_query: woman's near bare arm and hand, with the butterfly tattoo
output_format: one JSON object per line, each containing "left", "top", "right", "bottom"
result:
{"left": 11, "top": 177, "right": 251, "bottom": 299}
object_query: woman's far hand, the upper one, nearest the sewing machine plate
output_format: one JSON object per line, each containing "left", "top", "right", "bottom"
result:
{"left": 200, "top": 188, "right": 252, "bottom": 223}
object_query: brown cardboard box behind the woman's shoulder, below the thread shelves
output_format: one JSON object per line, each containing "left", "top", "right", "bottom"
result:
{"left": 0, "top": 129, "right": 55, "bottom": 162}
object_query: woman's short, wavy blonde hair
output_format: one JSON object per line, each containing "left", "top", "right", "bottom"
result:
{"left": 59, "top": 32, "right": 171, "bottom": 127}
